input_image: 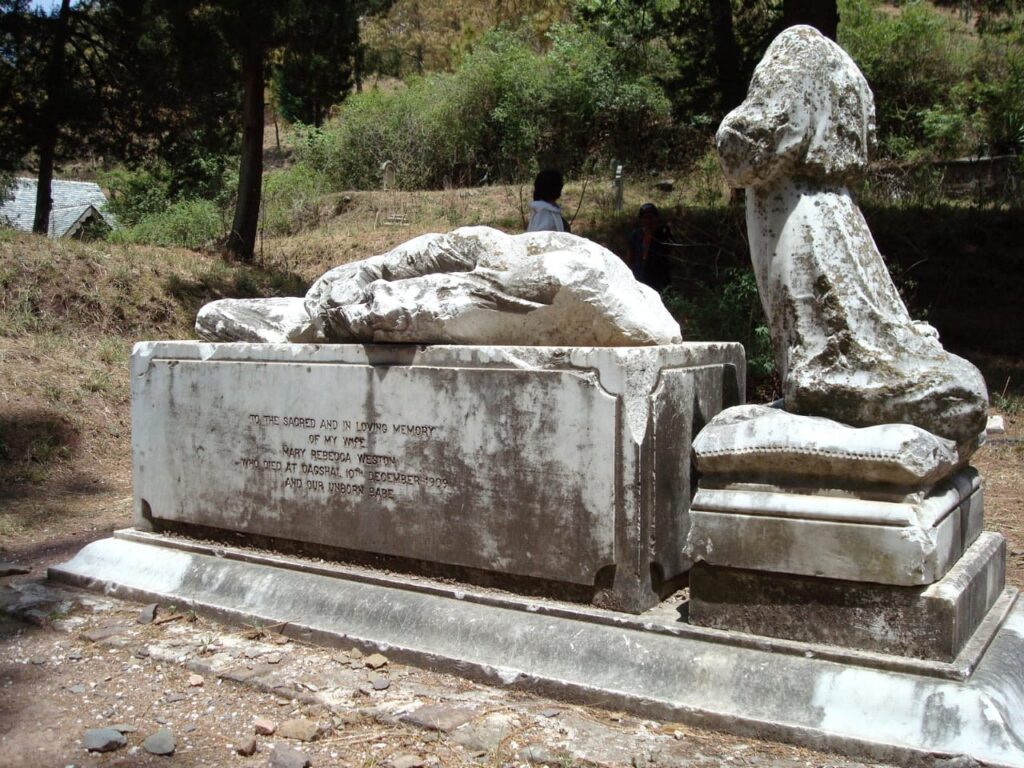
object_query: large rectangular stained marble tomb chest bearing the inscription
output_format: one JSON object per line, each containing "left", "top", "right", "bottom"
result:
{"left": 132, "top": 342, "right": 743, "bottom": 611}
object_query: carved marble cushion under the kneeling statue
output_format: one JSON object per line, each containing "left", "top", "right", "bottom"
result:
{"left": 693, "top": 404, "right": 957, "bottom": 493}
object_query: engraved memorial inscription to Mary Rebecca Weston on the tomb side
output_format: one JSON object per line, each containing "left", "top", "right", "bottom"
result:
{"left": 236, "top": 414, "right": 454, "bottom": 501}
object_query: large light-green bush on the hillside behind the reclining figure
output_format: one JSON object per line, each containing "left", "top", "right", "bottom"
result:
{"left": 297, "top": 27, "right": 670, "bottom": 188}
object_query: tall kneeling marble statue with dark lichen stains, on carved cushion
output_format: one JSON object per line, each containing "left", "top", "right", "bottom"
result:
{"left": 717, "top": 27, "right": 988, "bottom": 450}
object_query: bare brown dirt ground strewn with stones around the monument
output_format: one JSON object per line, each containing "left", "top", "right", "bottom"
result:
{"left": 0, "top": 415, "right": 1024, "bottom": 768}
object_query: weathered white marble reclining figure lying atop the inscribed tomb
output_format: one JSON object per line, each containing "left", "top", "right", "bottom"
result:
{"left": 196, "top": 226, "right": 682, "bottom": 346}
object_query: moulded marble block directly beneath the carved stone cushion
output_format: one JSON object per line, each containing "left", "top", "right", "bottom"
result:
{"left": 686, "top": 468, "right": 984, "bottom": 595}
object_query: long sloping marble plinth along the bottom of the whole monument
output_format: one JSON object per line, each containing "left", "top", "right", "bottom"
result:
{"left": 50, "top": 539, "right": 1024, "bottom": 768}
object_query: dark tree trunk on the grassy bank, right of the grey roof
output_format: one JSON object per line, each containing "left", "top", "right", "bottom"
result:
{"left": 227, "top": 43, "right": 265, "bottom": 261}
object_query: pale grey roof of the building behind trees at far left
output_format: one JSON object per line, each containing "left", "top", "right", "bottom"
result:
{"left": 0, "top": 178, "right": 117, "bottom": 238}
